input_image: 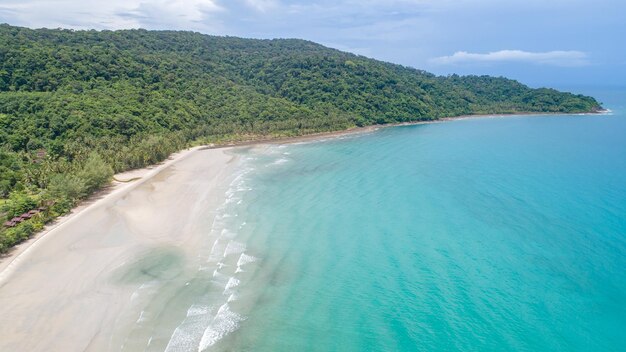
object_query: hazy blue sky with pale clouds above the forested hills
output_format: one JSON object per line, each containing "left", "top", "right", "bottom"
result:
{"left": 0, "top": 0, "right": 626, "bottom": 87}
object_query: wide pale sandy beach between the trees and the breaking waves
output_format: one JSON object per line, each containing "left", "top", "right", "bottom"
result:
{"left": 0, "top": 126, "right": 380, "bottom": 351}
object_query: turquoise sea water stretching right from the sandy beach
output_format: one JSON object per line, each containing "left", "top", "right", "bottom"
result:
{"left": 214, "top": 90, "right": 626, "bottom": 351}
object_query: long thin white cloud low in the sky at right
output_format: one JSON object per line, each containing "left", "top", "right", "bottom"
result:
{"left": 431, "top": 50, "right": 589, "bottom": 66}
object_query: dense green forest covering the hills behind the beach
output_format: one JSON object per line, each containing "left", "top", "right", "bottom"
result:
{"left": 0, "top": 25, "right": 600, "bottom": 253}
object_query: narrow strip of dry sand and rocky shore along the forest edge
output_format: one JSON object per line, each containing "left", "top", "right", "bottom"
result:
{"left": 0, "top": 109, "right": 611, "bottom": 272}
